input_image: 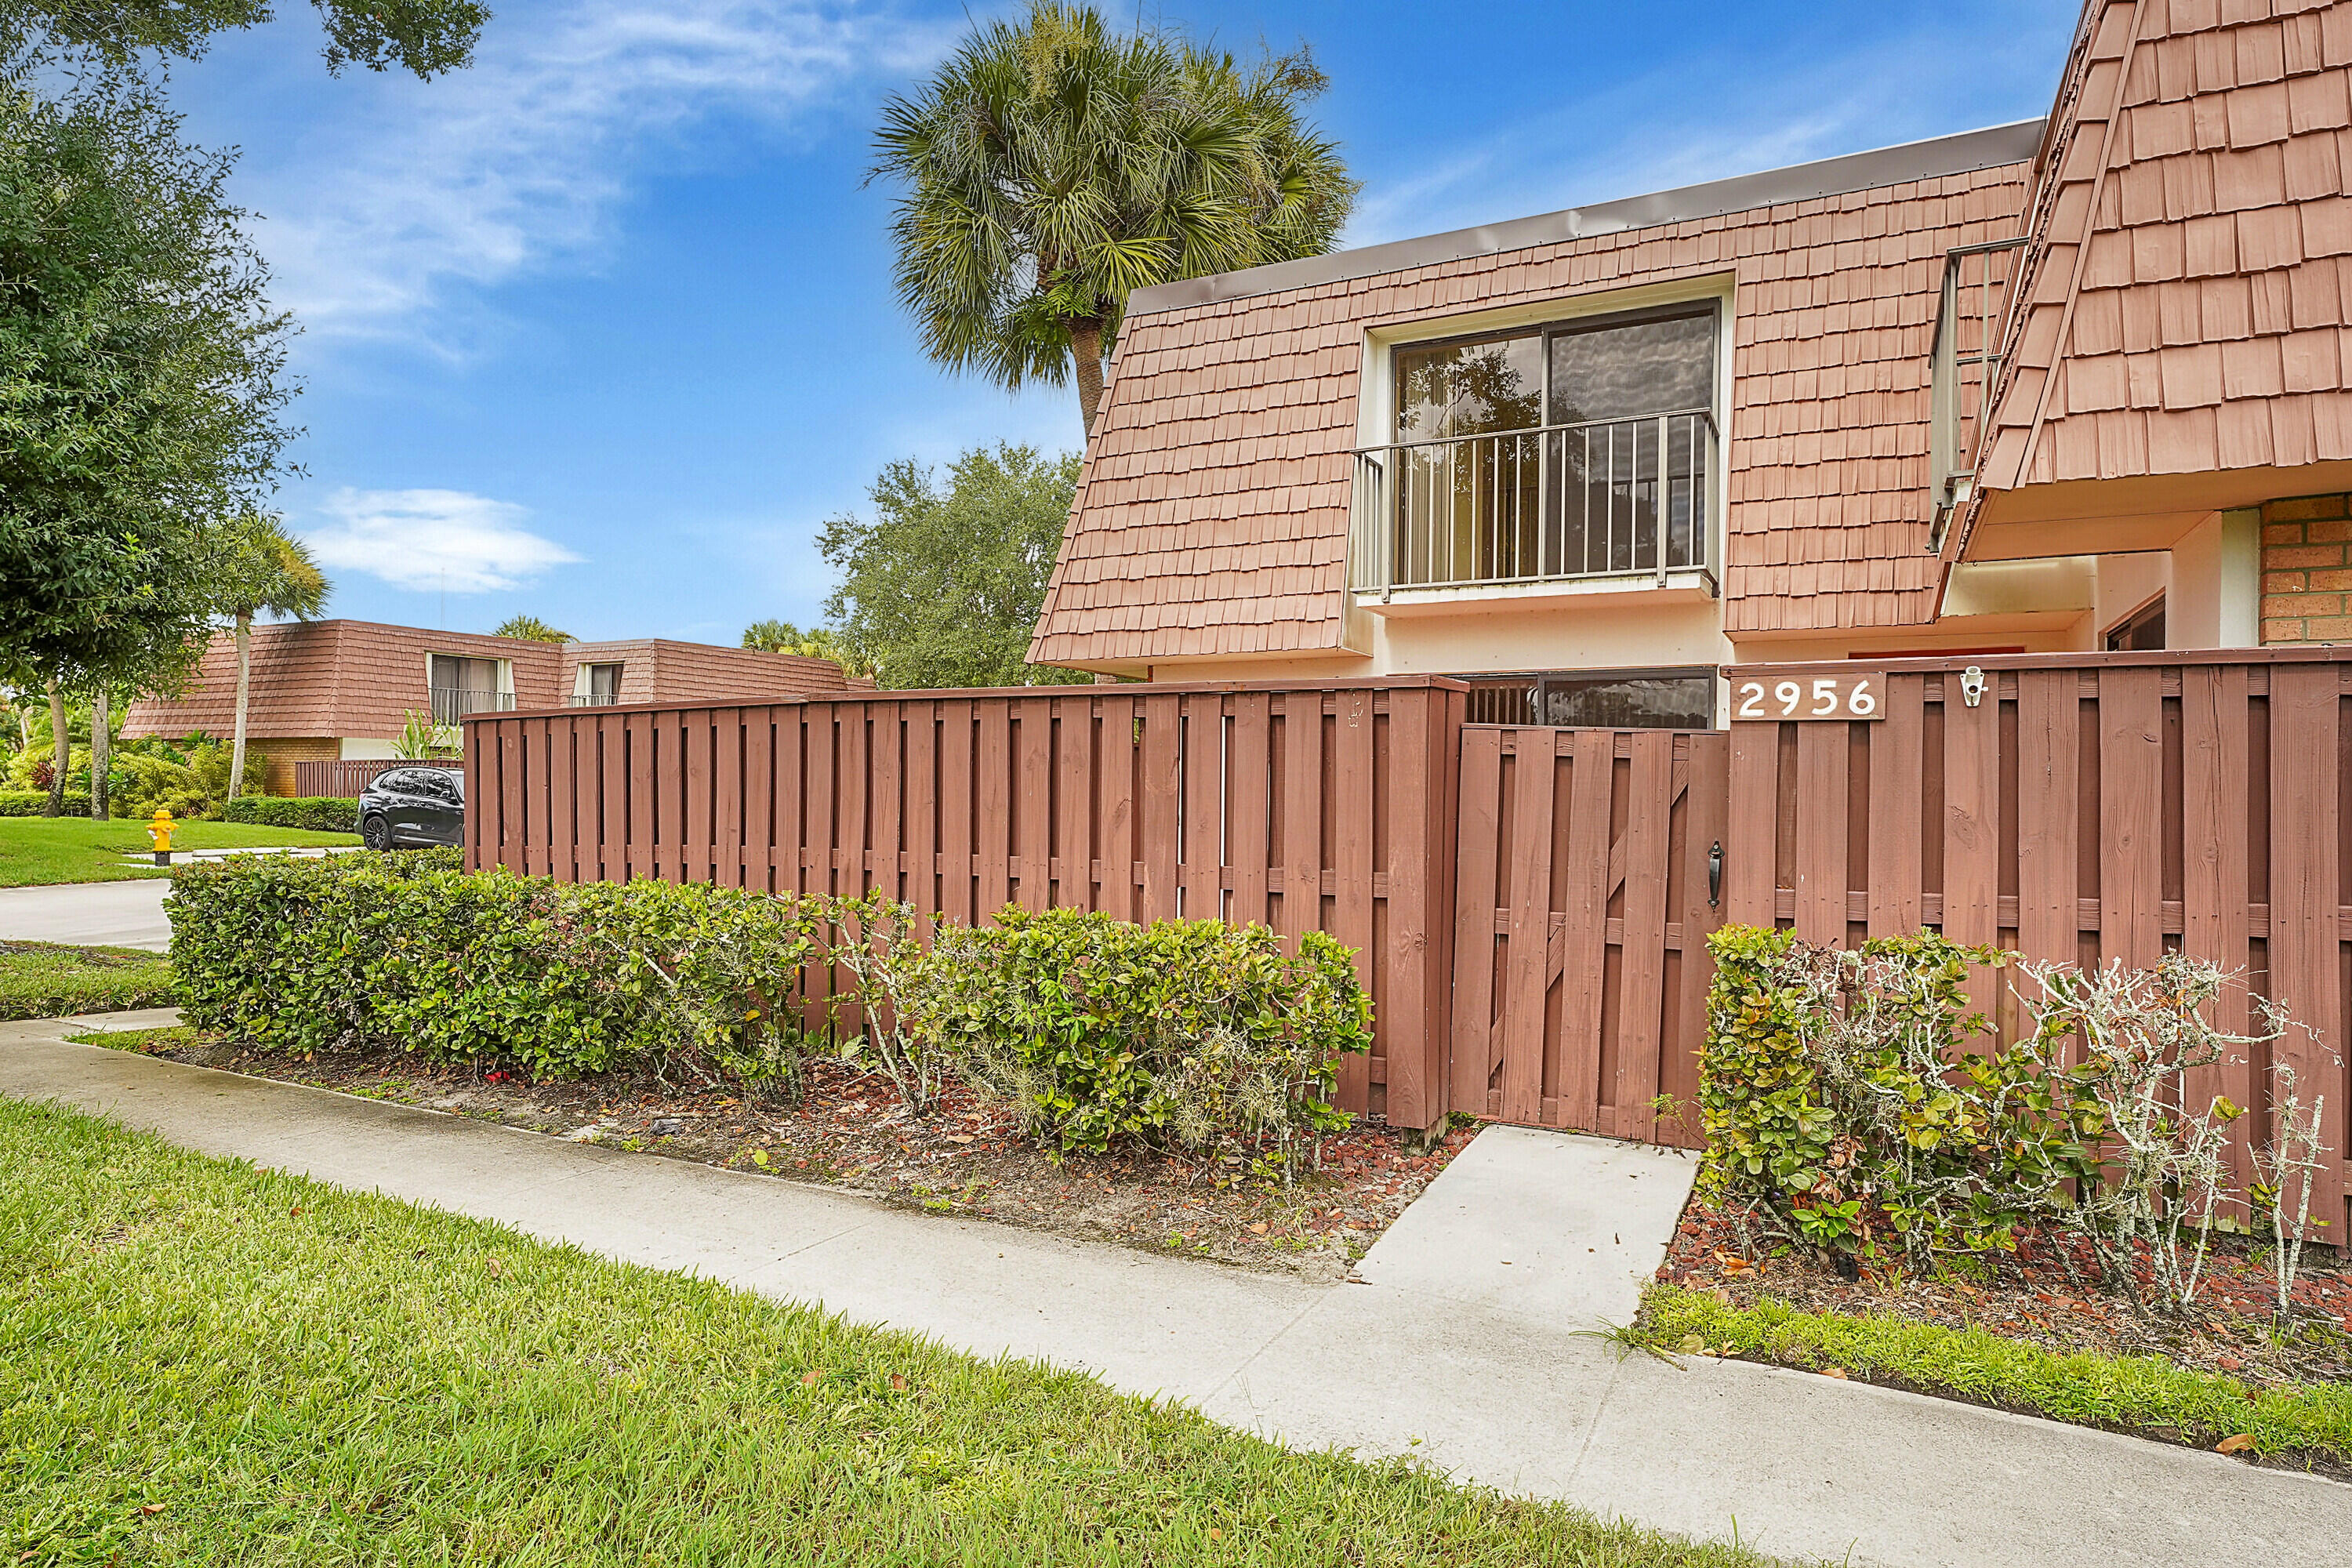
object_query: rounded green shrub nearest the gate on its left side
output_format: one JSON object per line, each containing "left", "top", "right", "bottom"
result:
{"left": 915, "top": 907, "right": 1371, "bottom": 1173}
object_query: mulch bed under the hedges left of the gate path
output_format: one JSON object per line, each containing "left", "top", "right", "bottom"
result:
{"left": 133, "top": 1039, "right": 1475, "bottom": 1279}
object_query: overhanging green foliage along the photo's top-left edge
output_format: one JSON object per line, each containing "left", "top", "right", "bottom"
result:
{"left": 0, "top": 0, "right": 489, "bottom": 78}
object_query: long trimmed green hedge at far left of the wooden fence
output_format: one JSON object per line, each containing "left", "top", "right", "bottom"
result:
{"left": 169, "top": 848, "right": 811, "bottom": 1081}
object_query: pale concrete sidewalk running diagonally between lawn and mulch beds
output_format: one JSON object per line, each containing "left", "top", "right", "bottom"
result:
{"left": 0, "top": 1015, "right": 2352, "bottom": 1568}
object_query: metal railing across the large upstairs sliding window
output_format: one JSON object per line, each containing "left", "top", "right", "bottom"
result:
{"left": 1348, "top": 409, "right": 1717, "bottom": 595}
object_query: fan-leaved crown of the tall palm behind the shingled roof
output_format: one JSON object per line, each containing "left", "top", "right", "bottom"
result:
{"left": 870, "top": 0, "right": 1357, "bottom": 440}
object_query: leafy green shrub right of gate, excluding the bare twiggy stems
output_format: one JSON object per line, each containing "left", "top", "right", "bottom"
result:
{"left": 1698, "top": 926, "right": 2098, "bottom": 1267}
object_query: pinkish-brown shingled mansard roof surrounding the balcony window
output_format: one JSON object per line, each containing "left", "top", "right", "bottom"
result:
{"left": 1030, "top": 143, "right": 2027, "bottom": 666}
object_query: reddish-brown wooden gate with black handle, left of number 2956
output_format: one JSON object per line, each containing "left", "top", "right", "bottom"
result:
{"left": 1451, "top": 724, "right": 1729, "bottom": 1145}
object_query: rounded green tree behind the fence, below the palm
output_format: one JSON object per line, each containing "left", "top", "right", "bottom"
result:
{"left": 823, "top": 445, "right": 1089, "bottom": 689}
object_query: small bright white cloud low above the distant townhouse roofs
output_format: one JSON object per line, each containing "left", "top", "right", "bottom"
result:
{"left": 306, "top": 489, "right": 581, "bottom": 593}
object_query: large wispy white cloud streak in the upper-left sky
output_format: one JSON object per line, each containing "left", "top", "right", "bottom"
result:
{"left": 240, "top": 0, "right": 938, "bottom": 353}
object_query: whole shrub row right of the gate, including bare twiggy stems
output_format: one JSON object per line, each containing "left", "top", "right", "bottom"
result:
{"left": 1700, "top": 926, "right": 2326, "bottom": 1316}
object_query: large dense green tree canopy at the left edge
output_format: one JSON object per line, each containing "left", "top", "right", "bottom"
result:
{"left": 0, "top": 73, "right": 292, "bottom": 687}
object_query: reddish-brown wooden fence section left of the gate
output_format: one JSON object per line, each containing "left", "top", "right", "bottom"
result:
{"left": 466, "top": 677, "right": 1465, "bottom": 1126}
